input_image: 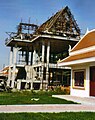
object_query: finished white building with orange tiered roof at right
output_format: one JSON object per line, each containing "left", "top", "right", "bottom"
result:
{"left": 58, "top": 29, "right": 95, "bottom": 97}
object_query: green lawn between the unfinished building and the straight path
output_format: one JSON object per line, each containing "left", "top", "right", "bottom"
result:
{"left": 0, "top": 91, "right": 74, "bottom": 105}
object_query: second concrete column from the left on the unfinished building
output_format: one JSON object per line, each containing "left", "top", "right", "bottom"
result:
{"left": 11, "top": 47, "right": 17, "bottom": 88}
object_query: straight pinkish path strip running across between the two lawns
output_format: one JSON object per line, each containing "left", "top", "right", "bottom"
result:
{"left": 0, "top": 104, "right": 95, "bottom": 113}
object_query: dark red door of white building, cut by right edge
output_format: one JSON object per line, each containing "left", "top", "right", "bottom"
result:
{"left": 90, "top": 66, "right": 95, "bottom": 96}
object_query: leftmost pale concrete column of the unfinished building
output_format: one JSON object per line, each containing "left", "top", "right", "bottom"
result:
{"left": 7, "top": 47, "right": 13, "bottom": 86}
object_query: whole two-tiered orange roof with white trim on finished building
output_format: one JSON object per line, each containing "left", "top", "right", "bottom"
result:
{"left": 59, "top": 30, "right": 95, "bottom": 66}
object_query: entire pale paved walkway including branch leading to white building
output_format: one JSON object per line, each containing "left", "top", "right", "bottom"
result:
{"left": 0, "top": 95, "right": 95, "bottom": 113}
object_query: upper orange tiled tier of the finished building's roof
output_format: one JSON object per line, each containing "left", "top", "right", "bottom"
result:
{"left": 71, "top": 30, "right": 95, "bottom": 52}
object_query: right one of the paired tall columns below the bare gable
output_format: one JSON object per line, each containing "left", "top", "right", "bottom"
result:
{"left": 46, "top": 42, "right": 50, "bottom": 89}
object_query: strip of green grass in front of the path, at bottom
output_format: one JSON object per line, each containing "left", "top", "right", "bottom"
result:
{"left": 0, "top": 112, "right": 95, "bottom": 120}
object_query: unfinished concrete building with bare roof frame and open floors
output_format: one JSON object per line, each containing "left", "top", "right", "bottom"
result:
{"left": 5, "top": 7, "right": 80, "bottom": 89}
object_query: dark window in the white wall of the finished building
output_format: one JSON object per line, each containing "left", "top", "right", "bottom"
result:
{"left": 74, "top": 70, "right": 85, "bottom": 87}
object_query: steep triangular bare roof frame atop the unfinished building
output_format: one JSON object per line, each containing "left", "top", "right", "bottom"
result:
{"left": 35, "top": 6, "right": 80, "bottom": 37}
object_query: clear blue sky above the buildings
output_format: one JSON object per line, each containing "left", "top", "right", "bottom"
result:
{"left": 0, "top": 0, "right": 95, "bottom": 69}
